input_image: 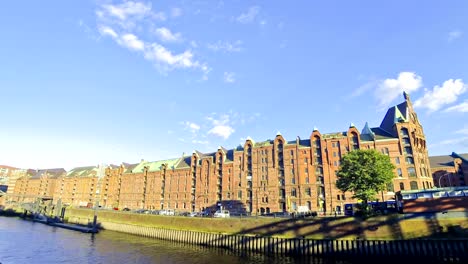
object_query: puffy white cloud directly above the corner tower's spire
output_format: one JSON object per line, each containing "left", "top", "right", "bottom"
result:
{"left": 375, "top": 72, "right": 422, "bottom": 107}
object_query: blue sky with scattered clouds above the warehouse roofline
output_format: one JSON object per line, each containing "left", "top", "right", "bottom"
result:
{"left": 0, "top": 0, "right": 468, "bottom": 169}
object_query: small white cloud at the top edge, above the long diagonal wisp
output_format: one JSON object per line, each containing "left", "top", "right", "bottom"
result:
{"left": 101, "top": 1, "right": 151, "bottom": 20}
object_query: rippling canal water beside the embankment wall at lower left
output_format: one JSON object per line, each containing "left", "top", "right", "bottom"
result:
{"left": 0, "top": 217, "right": 351, "bottom": 264}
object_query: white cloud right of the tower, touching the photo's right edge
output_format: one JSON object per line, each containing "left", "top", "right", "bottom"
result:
{"left": 414, "top": 79, "right": 468, "bottom": 112}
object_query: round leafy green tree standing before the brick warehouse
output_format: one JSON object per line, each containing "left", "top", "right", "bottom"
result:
{"left": 336, "top": 149, "right": 395, "bottom": 212}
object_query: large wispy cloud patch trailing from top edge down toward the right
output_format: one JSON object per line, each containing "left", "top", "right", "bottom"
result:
{"left": 96, "top": 1, "right": 211, "bottom": 77}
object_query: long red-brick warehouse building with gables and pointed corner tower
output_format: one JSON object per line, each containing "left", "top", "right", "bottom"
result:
{"left": 5, "top": 93, "right": 434, "bottom": 214}
